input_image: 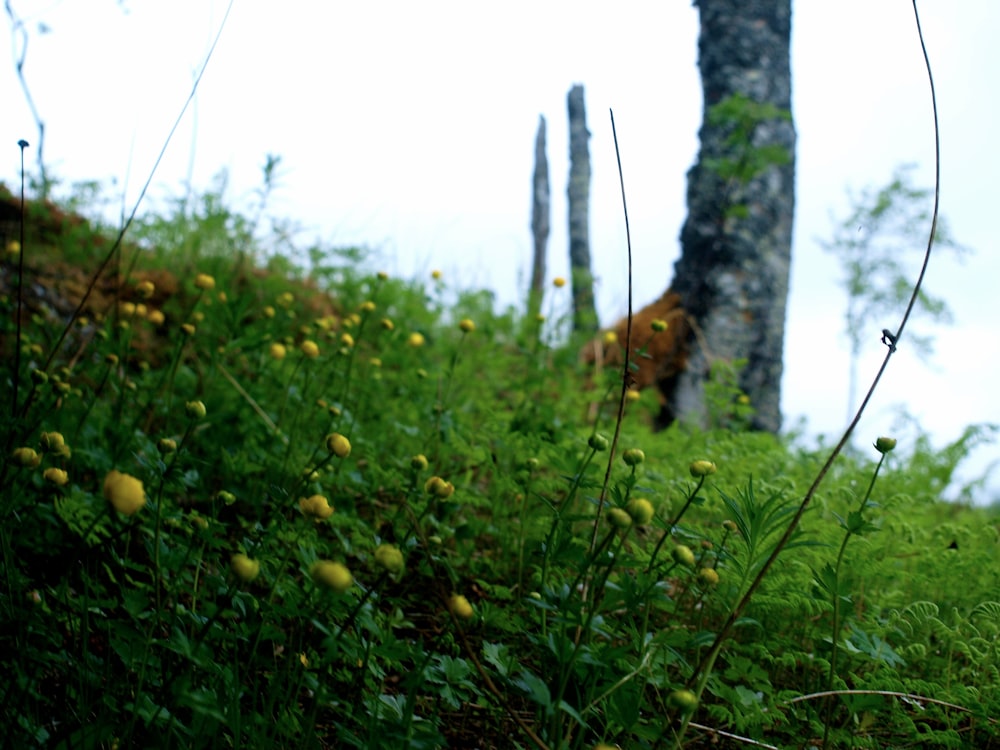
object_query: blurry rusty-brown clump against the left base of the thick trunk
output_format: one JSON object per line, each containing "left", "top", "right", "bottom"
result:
{"left": 581, "top": 289, "right": 690, "bottom": 427}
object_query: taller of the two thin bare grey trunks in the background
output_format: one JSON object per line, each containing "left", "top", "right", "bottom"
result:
{"left": 567, "top": 84, "right": 597, "bottom": 332}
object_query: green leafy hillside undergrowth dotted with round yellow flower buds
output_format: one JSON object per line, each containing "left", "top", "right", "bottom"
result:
{"left": 0, "top": 184, "right": 1000, "bottom": 749}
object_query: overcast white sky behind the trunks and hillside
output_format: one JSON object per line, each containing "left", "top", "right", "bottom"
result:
{"left": 0, "top": 0, "right": 1000, "bottom": 506}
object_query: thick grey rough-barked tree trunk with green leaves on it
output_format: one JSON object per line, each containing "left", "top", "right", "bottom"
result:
{"left": 660, "top": 0, "right": 795, "bottom": 432}
